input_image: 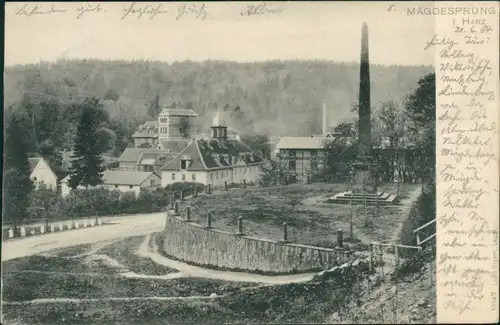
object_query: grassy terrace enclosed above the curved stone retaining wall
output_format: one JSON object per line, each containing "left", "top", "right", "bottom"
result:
{"left": 191, "top": 184, "right": 416, "bottom": 247}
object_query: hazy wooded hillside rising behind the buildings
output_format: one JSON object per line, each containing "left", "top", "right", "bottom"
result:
{"left": 4, "top": 60, "right": 434, "bottom": 137}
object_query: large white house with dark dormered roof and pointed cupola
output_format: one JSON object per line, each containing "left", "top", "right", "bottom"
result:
{"left": 161, "top": 110, "right": 264, "bottom": 187}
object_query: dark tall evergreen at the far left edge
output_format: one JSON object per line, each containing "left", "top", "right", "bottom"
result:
{"left": 4, "top": 114, "right": 33, "bottom": 229}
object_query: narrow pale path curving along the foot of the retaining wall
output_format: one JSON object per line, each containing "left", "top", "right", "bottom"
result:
{"left": 137, "top": 235, "right": 316, "bottom": 284}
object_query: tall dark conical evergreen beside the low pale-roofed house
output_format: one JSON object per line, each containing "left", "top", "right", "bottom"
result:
{"left": 68, "top": 98, "right": 104, "bottom": 189}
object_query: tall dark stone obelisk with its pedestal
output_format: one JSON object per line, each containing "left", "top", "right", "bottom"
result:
{"left": 352, "top": 23, "right": 377, "bottom": 194}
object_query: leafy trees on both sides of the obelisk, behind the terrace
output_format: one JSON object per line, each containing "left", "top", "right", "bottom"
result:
{"left": 324, "top": 73, "right": 436, "bottom": 187}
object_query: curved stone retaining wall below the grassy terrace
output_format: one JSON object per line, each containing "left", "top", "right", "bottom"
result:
{"left": 163, "top": 210, "right": 351, "bottom": 273}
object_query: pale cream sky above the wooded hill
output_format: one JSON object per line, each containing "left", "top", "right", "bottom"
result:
{"left": 5, "top": 1, "right": 434, "bottom": 66}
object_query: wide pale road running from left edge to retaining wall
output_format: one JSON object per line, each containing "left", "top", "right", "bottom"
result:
{"left": 2, "top": 212, "right": 165, "bottom": 261}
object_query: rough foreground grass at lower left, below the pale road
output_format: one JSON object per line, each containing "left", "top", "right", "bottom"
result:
{"left": 2, "top": 236, "right": 255, "bottom": 301}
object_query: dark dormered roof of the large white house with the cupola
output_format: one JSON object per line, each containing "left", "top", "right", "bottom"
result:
{"left": 162, "top": 139, "right": 263, "bottom": 171}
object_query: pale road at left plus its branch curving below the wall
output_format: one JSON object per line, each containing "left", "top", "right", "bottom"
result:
{"left": 2, "top": 213, "right": 316, "bottom": 284}
